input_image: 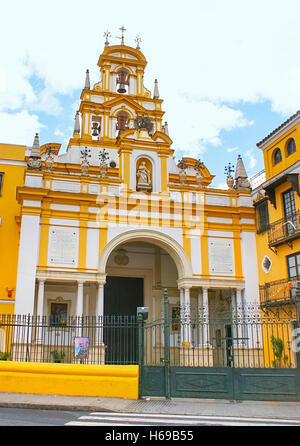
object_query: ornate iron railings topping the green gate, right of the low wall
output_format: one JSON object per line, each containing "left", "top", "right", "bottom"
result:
{"left": 143, "top": 304, "right": 297, "bottom": 368}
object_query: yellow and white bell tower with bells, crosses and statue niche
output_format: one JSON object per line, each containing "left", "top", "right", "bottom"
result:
{"left": 67, "top": 27, "right": 173, "bottom": 192}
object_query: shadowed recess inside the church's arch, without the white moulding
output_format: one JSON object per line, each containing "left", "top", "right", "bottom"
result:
{"left": 104, "top": 240, "right": 179, "bottom": 319}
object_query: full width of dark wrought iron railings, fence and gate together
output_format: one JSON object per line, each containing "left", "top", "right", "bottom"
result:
{"left": 0, "top": 305, "right": 297, "bottom": 368}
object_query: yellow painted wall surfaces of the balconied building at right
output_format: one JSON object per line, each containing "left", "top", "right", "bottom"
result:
{"left": 256, "top": 116, "right": 300, "bottom": 367}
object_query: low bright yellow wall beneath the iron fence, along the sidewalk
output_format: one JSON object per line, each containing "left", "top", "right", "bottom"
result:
{"left": 0, "top": 361, "right": 139, "bottom": 399}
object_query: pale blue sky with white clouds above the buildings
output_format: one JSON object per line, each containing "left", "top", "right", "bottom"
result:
{"left": 0, "top": 0, "right": 300, "bottom": 188}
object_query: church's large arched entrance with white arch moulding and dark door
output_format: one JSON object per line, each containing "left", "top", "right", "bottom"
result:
{"left": 99, "top": 230, "right": 190, "bottom": 364}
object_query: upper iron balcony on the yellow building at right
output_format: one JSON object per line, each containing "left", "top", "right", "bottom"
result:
{"left": 268, "top": 211, "right": 300, "bottom": 248}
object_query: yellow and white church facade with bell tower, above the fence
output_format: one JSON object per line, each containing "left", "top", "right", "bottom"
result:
{"left": 0, "top": 35, "right": 259, "bottom": 328}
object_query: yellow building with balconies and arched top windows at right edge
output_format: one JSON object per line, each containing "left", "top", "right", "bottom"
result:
{"left": 254, "top": 112, "right": 300, "bottom": 313}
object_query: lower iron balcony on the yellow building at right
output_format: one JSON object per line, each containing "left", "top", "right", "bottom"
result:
{"left": 259, "top": 277, "right": 300, "bottom": 307}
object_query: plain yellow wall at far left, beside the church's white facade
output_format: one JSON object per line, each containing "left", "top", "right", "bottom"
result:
{"left": 0, "top": 144, "right": 26, "bottom": 308}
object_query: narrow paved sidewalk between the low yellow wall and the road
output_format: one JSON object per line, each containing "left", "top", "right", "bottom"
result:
{"left": 0, "top": 393, "right": 300, "bottom": 422}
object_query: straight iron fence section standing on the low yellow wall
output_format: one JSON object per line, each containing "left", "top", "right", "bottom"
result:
{"left": 0, "top": 315, "right": 137, "bottom": 364}
